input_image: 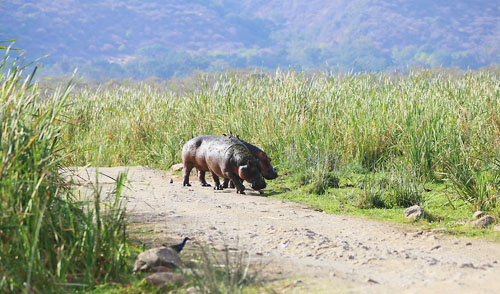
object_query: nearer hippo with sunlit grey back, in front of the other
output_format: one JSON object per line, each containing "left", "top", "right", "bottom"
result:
{"left": 182, "top": 135, "right": 266, "bottom": 194}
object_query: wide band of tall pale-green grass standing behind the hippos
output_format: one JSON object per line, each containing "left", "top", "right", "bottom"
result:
{"left": 59, "top": 70, "right": 500, "bottom": 210}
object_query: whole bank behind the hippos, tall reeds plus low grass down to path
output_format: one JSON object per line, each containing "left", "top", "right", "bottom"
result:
{"left": 62, "top": 69, "right": 500, "bottom": 230}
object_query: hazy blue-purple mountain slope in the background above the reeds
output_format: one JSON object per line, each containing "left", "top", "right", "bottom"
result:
{"left": 0, "top": 0, "right": 500, "bottom": 78}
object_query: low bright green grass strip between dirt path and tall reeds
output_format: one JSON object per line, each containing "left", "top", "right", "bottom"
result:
{"left": 268, "top": 174, "right": 500, "bottom": 240}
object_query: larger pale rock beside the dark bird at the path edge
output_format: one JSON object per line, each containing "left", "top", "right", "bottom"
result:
{"left": 133, "top": 247, "right": 181, "bottom": 273}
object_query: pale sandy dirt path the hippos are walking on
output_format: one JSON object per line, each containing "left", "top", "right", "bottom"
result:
{"left": 72, "top": 167, "right": 500, "bottom": 293}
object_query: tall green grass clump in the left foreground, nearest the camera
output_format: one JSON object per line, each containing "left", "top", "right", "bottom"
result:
{"left": 0, "top": 52, "right": 128, "bottom": 293}
